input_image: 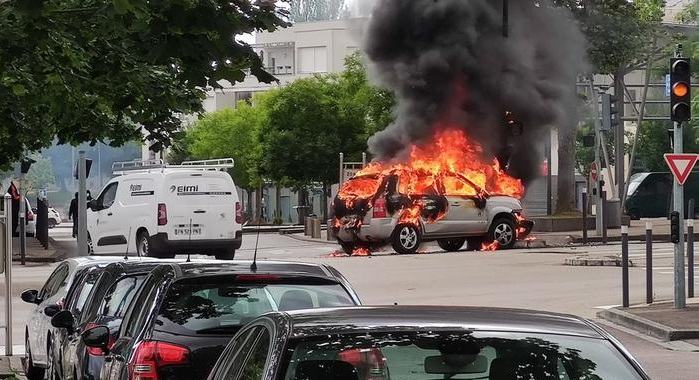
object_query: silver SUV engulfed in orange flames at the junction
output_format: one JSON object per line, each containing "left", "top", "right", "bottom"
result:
{"left": 333, "top": 131, "right": 534, "bottom": 254}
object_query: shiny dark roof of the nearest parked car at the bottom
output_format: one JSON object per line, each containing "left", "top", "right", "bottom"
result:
{"left": 285, "top": 306, "right": 604, "bottom": 339}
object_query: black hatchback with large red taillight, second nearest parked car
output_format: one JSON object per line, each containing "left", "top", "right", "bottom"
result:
{"left": 82, "top": 261, "right": 359, "bottom": 380}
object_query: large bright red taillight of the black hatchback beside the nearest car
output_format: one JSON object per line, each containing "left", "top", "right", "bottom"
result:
{"left": 129, "top": 340, "right": 189, "bottom": 380}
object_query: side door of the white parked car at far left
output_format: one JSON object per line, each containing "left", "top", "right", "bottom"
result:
{"left": 27, "top": 263, "right": 70, "bottom": 364}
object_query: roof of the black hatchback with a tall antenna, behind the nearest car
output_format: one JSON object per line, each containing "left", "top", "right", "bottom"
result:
{"left": 171, "top": 260, "right": 336, "bottom": 279}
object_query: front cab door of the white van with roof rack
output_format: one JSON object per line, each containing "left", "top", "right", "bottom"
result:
{"left": 91, "top": 182, "right": 128, "bottom": 253}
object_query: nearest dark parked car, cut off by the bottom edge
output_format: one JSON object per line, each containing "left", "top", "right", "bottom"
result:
{"left": 197, "top": 306, "right": 649, "bottom": 380}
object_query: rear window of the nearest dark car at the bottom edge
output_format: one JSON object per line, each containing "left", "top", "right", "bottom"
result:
{"left": 279, "top": 330, "right": 642, "bottom": 380}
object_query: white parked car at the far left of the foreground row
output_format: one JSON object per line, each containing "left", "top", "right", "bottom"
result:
{"left": 21, "top": 256, "right": 123, "bottom": 380}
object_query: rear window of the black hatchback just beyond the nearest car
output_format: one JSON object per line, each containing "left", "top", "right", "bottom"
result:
{"left": 156, "top": 281, "right": 355, "bottom": 334}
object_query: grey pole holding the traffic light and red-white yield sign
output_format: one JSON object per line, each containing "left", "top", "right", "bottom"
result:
{"left": 672, "top": 46, "right": 686, "bottom": 309}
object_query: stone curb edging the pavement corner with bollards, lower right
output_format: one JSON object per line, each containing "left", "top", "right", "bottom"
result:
{"left": 597, "top": 308, "right": 699, "bottom": 342}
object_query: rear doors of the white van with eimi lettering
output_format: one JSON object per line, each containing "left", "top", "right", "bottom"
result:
{"left": 163, "top": 171, "right": 238, "bottom": 240}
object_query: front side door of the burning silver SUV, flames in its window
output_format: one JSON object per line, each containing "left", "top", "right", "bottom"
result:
{"left": 441, "top": 175, "right": 488, "bottom": 235}
